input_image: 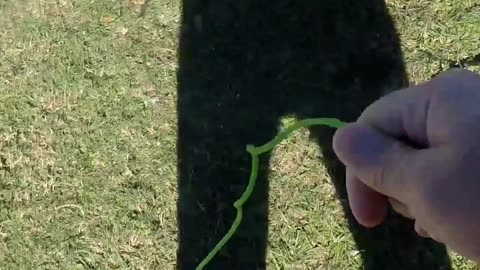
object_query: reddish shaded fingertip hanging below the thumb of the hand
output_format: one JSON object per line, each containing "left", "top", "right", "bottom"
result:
{"left": 346, "top": 169, "right": 388, "bottom": 228}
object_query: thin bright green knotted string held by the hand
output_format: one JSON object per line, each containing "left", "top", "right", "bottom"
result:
{"left": 196, "top": 118, "right": 346, "bottom": 270}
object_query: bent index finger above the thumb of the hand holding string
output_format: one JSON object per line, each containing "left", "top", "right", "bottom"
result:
{"left": 357, "top": 69, "right": 480, "bottom": 148}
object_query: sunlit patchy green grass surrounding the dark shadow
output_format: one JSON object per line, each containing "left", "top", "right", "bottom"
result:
{"left": 0, "top": 0, "right": 480, "bottom": 270}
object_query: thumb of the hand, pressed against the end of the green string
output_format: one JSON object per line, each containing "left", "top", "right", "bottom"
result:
{"left": 333, "top": 123, "right": 420, "bottom": 200}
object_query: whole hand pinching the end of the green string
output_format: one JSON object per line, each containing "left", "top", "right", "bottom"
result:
{"left": 333, "top": 69, "right": 480, "bottom": 262}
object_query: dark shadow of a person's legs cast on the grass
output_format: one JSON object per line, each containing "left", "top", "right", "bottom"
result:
{"left": 177, "top": 0, "right": 450, "bottom": 270}
